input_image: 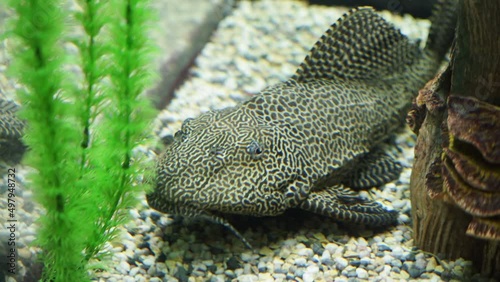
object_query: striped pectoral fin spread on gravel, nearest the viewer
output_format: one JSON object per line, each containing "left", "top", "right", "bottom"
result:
{"left": 299, "top": 185, "right": 398, "bottom": 226}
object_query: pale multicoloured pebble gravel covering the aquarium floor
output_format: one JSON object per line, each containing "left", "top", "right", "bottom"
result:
{"left": 0, "top": 1, "right": 492, "bottom": 282}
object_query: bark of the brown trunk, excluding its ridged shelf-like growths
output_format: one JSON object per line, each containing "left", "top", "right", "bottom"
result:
{"left": 410, "top": 0, "right": 500, "bottom": 279}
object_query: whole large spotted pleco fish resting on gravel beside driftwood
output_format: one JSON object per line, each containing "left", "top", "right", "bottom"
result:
{"left": 147, "top": 1, "right": 456, "bottom": 246}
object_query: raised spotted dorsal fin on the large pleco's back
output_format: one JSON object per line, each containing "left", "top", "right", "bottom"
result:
{"left": 292, "top": 7, "right": 419, "bottom": 82}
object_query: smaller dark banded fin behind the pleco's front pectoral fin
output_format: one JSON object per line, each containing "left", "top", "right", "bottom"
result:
{"left": 342, "top": 148, "right": 403, "bottom": 190}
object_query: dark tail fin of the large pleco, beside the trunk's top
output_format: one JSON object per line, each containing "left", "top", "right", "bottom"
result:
{"left": 425, "top": 0, "right": 458, "bottom": 61}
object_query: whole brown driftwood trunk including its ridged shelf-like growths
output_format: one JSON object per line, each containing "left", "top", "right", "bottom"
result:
{"left": 408, "top": 0, "right": 500, "bottom": 279}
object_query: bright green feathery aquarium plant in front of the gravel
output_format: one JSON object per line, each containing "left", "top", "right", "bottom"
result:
{"left": 5, "top": 0, "right": 153, "bottom": 281}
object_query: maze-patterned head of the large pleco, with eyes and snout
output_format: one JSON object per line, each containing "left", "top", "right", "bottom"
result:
{"left": 148, "top": 106, "right": 288, "bottom": 216}
